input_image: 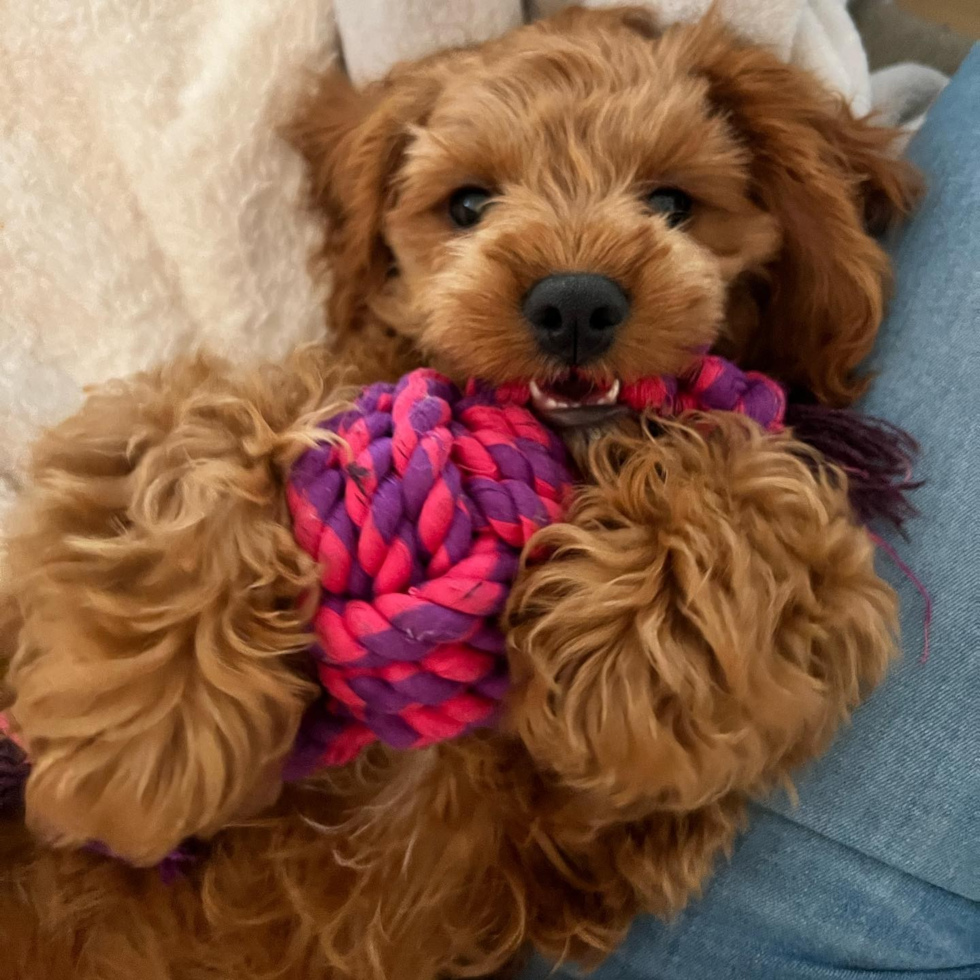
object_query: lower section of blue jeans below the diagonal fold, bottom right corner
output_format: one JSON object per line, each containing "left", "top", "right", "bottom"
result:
{"left": 522, "top": 810, "right": 980, "bottom": 980}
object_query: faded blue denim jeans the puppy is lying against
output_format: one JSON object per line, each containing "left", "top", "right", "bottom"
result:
{"left": 525, "top": 46, "right": 980, "bottom": 980}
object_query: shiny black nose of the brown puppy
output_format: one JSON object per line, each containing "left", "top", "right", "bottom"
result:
{"left": 523, "top": 272, "right": 630, "bottom": 365}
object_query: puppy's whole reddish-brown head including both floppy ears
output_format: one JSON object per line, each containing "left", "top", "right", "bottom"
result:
{"left": 295, "top": 9, "right": 914, "bottom": 414}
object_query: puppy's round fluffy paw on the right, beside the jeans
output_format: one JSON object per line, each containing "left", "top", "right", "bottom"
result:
{"left": 508, "top": 415, "right": 895, "bottom": 810}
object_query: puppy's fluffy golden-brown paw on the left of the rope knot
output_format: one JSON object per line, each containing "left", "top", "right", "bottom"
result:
{"left": 6, "top": 354, "right": 336, "bottom": 864}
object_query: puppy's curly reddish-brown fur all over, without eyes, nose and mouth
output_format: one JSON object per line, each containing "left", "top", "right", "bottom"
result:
{"left": 0, "top": 10, "right": 914, "bottom": 980}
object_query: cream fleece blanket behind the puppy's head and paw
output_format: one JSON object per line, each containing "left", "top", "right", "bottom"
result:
{"left": 0, "top": 0, "right": 944, "bottom": 528}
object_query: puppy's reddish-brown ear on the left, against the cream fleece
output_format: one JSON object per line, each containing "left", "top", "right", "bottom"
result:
{"left": 287, "top": 65, "right": 442, "bottom": 332}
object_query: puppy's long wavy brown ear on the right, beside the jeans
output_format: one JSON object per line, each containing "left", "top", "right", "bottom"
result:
{"left": 678, "top": 23, "right": 921, "bottom": 405}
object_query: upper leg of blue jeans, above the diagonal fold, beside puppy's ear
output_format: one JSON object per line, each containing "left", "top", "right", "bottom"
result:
{"left": 775, "top": 46, "right": 980, "bottom": 904}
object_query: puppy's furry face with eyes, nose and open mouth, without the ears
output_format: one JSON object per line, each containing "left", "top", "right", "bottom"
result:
{"left": 384, "top": 37, "right": 779, "bottom": 420}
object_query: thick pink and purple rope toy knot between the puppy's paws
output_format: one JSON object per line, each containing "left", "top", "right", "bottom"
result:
{"left": 288, "top": 370, "right": 572, "bottom": 772}
